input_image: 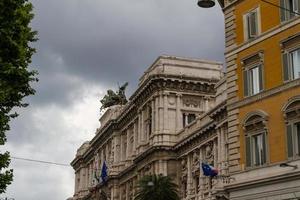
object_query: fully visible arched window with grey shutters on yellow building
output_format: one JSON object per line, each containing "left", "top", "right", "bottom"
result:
{"left": 243, "top": 111, "right": 268, "bottom": 167}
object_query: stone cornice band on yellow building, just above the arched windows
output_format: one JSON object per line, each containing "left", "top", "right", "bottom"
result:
{"left": 227, "top": 79, "right": 300, "bottom": 110}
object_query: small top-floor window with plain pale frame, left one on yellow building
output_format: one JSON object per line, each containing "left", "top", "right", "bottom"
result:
{"left": 244, "top": 8, "right": 260, "bottom": 40}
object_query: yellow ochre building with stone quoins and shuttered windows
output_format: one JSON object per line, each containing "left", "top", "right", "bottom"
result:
{"left": 219, "top": 0, "right": 300, "bottom": 200}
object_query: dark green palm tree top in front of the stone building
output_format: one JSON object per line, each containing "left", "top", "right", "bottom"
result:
{"left": 134, "top": 175, "right": 180, "bottom": 200}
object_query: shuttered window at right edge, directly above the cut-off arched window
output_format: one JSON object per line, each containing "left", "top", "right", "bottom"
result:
{"left": 283, "top": 48, "right": 300, "bottom": 81}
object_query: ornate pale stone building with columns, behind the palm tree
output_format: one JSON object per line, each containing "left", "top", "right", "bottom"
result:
{"left": 71, "top": 56, "right": 230, "bottom": 200}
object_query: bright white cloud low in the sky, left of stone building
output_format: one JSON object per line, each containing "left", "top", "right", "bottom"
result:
{"left": 3, "top": 84, "right": 104, "bottom": 200}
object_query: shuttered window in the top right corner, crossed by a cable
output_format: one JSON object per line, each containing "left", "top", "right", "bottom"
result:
{"left": 280, "top": 0, "right": 300, "bottom": 22}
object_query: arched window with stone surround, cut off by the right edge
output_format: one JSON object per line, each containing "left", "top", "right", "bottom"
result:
{"left": 283, "top": 96, "right": 300, "bottom": 159}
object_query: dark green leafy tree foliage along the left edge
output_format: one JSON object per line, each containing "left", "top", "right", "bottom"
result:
{"left": 0, "top": 0, "right": 37, "bottom": 194}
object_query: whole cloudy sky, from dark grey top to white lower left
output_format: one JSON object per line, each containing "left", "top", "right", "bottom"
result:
{"left": 1, "top": 0, "right": 224, "bottom": 200}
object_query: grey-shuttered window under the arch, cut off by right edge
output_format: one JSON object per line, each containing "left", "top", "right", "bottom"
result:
{"left": 287, "top": 122, "right": 300, "bottom": 158}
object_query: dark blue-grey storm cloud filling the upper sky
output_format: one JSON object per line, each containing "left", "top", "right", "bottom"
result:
{"left": 29, "top": 0, "right": 224, "bottom": 106}
